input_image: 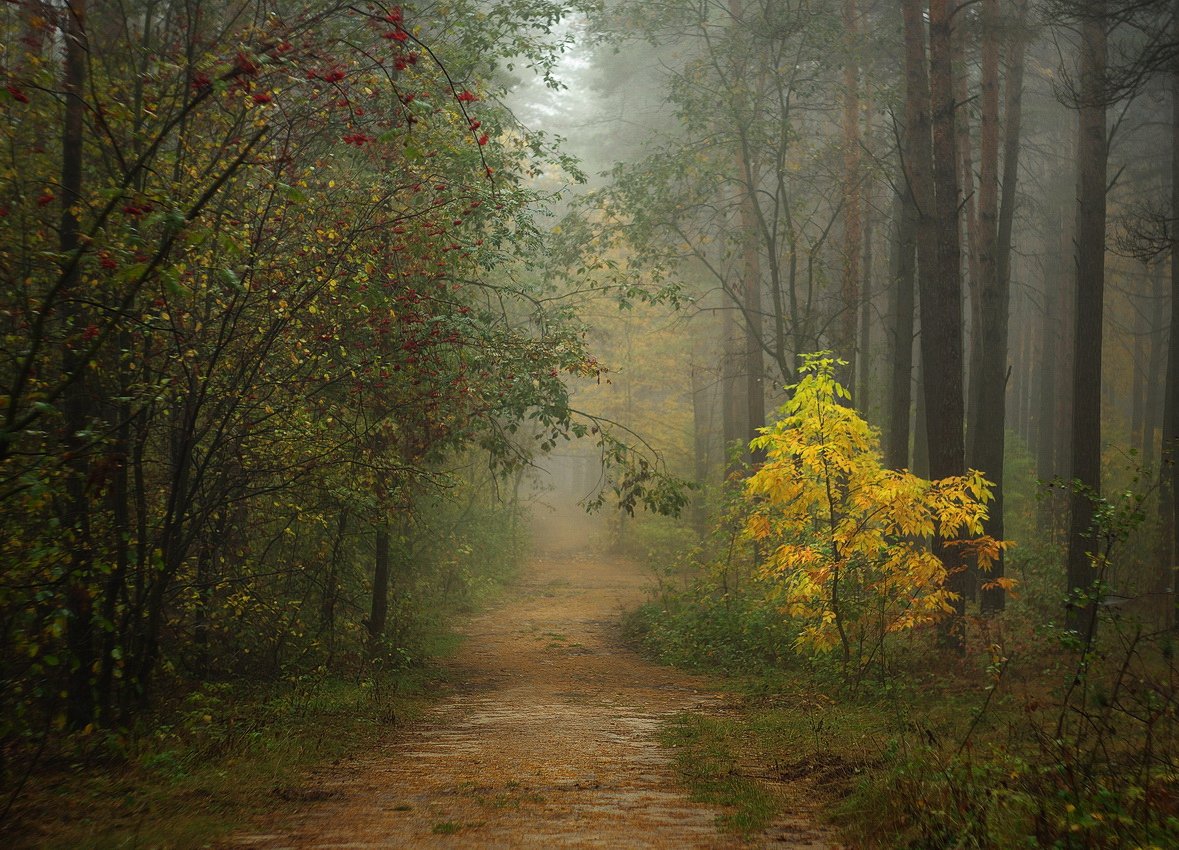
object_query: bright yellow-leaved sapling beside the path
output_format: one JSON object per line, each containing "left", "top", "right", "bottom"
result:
{"left": 745, "top": 354, "right": 1012, "bottom": 673}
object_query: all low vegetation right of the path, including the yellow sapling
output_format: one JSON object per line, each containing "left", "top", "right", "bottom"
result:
{"left": 641, "top": 370, "right": 1179, "bottom": 850}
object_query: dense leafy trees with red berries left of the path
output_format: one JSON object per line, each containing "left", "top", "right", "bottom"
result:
{"left": 0, "top": 0, "right": 683, "bottom": 749}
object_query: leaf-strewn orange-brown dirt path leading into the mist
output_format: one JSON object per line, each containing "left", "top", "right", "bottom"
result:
{"left": 228, "top": 506, "right": 832, "bottom": 850}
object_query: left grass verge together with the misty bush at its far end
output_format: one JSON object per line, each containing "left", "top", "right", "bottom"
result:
{"left": 0, "top": 495, "right": 525, "bottom": 849}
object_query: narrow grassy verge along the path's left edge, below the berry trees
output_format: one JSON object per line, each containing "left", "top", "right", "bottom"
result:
{"left": 0, "top": 516, "right": 523, "bottom": 850}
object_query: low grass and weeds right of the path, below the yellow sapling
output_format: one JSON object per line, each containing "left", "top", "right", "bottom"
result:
{"left": 636, "top": 608, "right": 1179, "bottom": 850}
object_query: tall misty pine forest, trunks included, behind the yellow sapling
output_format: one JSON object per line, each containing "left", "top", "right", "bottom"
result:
{"left": 547, "top": 1, "right": 1175, "bottom": 631}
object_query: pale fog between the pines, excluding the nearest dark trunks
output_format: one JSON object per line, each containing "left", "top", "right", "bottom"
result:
{"left": 507, "top": 2, "right": 1172, "bottom": 608}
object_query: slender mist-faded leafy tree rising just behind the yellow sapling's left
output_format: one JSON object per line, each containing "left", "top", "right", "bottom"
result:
{"left": 562, "top": 0, "right": 862, "bottom": 450}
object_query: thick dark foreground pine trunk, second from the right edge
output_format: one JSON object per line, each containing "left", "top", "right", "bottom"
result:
{"left": 1067, "top": 0, "right": 1107, "bottom": 634}
